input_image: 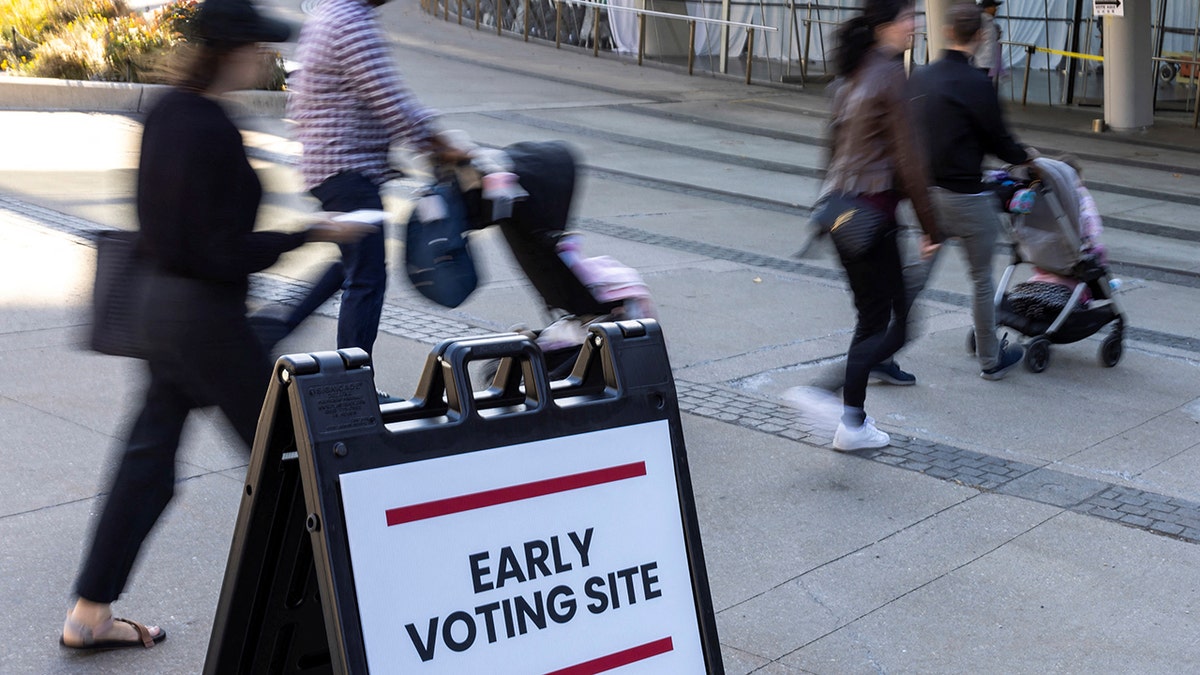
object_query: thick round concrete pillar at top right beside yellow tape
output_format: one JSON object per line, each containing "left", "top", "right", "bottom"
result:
{"left": 1104, "top": 1, "right": 1154, "bottom": 131}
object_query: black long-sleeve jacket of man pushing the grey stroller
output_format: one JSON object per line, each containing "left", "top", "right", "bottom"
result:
{"left": 911, "top": 49, "right": 1030, "bottom": 195}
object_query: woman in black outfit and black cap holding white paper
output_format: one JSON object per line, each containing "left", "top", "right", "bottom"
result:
{"left": 61, "top": 0, "right": 366, "bottom": 649}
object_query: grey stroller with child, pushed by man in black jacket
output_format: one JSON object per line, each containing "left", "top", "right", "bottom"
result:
{"left": 967, "top": 157, "right": 1124, "bottom": 372}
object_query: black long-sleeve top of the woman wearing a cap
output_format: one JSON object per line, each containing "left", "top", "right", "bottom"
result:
{"left": 137, "top": 90, "right": 305, "bottom": 288}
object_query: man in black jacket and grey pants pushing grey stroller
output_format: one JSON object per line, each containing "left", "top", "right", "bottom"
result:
{"left": 911, "top": 4, "right": 1036, "bottom": 380}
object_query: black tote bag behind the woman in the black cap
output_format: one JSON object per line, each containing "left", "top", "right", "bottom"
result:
{"left": 90, "top": 231, "right": 146, "bottom": 359}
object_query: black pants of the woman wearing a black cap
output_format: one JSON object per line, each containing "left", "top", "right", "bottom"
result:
{"left": 76, "top": 276, "right": 271, "bottom": 603}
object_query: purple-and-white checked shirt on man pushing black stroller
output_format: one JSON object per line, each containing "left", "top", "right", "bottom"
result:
{"left": 288, "top": 0, "right": 436, "bottom": 190}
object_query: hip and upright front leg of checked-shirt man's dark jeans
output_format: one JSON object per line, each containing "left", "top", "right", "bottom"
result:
{"left": 312, "top": 172, "right": 388, "bottom": 354}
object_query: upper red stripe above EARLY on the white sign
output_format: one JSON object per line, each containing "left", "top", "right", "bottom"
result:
{"left": 385, "top": 461, "right": 646, "bottom": 527}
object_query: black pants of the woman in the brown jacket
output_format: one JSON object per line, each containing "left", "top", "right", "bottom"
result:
{"left": 842, "top": 227, "right": 910, "bottom": 426}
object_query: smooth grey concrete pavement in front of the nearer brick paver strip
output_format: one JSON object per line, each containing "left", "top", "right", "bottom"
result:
{"left": 0, "top": 182, "right": 1200, "bottom": 674}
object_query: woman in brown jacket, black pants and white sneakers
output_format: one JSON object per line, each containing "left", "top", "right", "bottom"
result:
{"left": 822, "top": 0, "right": 941, "bottom": 452}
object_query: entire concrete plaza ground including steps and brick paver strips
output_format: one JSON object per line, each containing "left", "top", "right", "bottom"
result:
{"left": 0, "top": 4, "right": 1200, "bottom": 674}
